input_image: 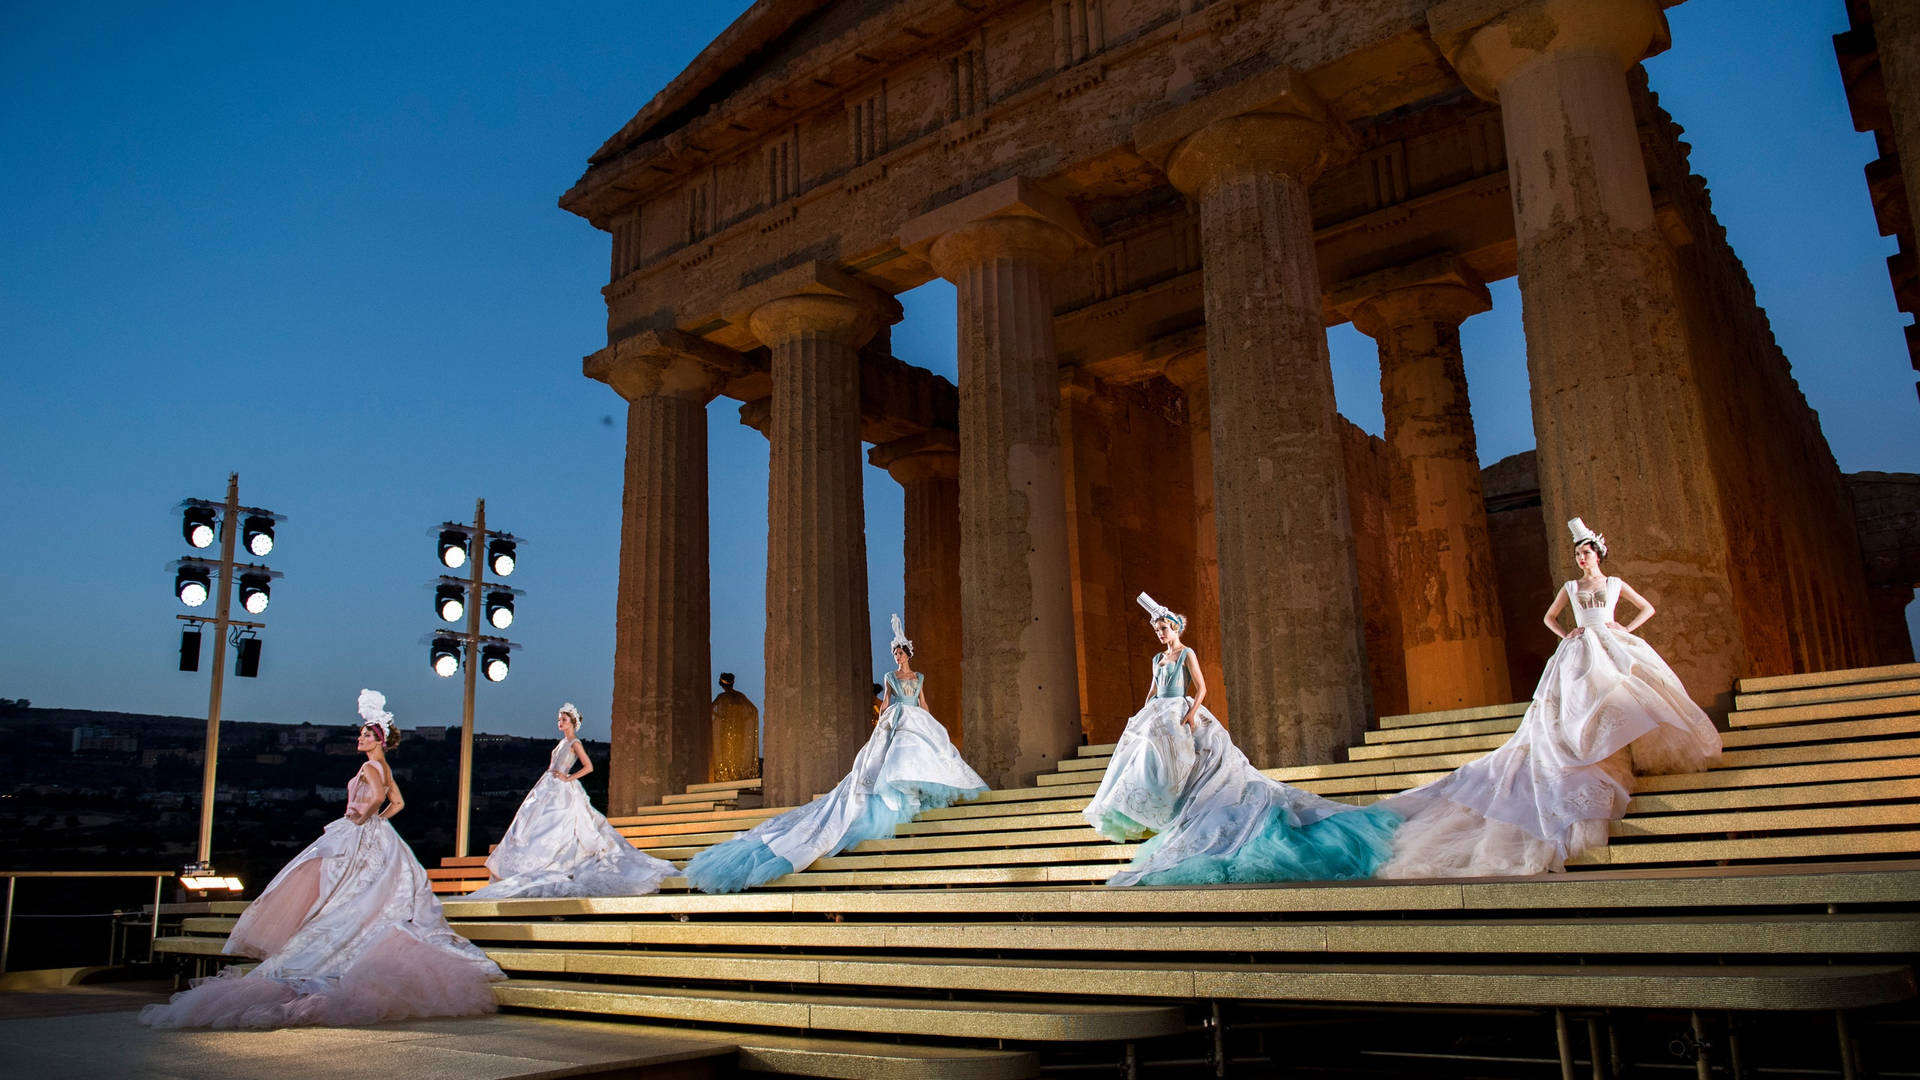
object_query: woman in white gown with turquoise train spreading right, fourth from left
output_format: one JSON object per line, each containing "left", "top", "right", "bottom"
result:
{"left": 1083, "top": 592, "right": 1400, "bottom": 886}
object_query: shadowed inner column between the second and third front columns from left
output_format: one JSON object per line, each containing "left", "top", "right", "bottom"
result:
{"left": 866, "top": 430, "right": 966, "bottom": 746}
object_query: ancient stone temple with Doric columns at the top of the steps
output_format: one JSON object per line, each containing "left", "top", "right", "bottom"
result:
{"left": 563, "top": 0, "right": 1920, "bottom": 813}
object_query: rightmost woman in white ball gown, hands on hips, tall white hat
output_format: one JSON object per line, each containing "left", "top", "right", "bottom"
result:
{"left": 1380, "top": 517, "right": 1720, "bottom": 878}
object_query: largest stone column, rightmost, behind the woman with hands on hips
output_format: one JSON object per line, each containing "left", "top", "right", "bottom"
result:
{"left": 1428, "top": 0, "right": 1745, "bottom": 707}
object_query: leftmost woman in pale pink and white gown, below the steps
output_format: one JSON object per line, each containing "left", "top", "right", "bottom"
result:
{"left": 140, "top": 690, "right": 507, "bottom": 1028}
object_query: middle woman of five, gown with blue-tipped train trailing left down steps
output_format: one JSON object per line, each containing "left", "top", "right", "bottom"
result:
{"left": 685, "top": 615, "right": 987, "bottom": 892}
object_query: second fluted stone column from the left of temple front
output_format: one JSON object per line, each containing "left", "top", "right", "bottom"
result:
{"left": 730, "top": 263, "right": 900, "bottom": 805}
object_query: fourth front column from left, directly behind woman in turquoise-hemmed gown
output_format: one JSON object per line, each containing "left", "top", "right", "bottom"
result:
{"left": 1133, "top": 69, "right": 1371, "bottom": 767}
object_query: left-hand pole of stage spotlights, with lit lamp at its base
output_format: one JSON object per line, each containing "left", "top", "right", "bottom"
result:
{"left": 171, "top": 473, "right": 286, "bottom": 892}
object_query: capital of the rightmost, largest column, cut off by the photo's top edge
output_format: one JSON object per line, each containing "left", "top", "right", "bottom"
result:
{"left": 1427, "top": 0, "right": 1672, "bottom": 102}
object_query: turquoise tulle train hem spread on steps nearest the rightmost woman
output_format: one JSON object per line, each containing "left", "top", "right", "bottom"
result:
{"left": 1135, "top": 807, "right": 1404, "bottom": 886}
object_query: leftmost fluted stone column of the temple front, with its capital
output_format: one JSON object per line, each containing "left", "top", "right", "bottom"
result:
{"left": 584, "top": 331, "right": 745, "bottom": 815}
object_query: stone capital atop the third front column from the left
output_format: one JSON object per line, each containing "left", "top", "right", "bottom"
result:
{"left": 899, "top": 177, "right": 1096, "bottom": 281}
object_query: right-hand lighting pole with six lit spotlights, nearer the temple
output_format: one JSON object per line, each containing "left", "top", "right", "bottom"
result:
{"left": 426, "top": 500, "right": 522, "bottom": 857}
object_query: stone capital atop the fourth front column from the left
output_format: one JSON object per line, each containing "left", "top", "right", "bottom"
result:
{"left": 1133, "top": 67, "right": 1348, "bottom": 198}
